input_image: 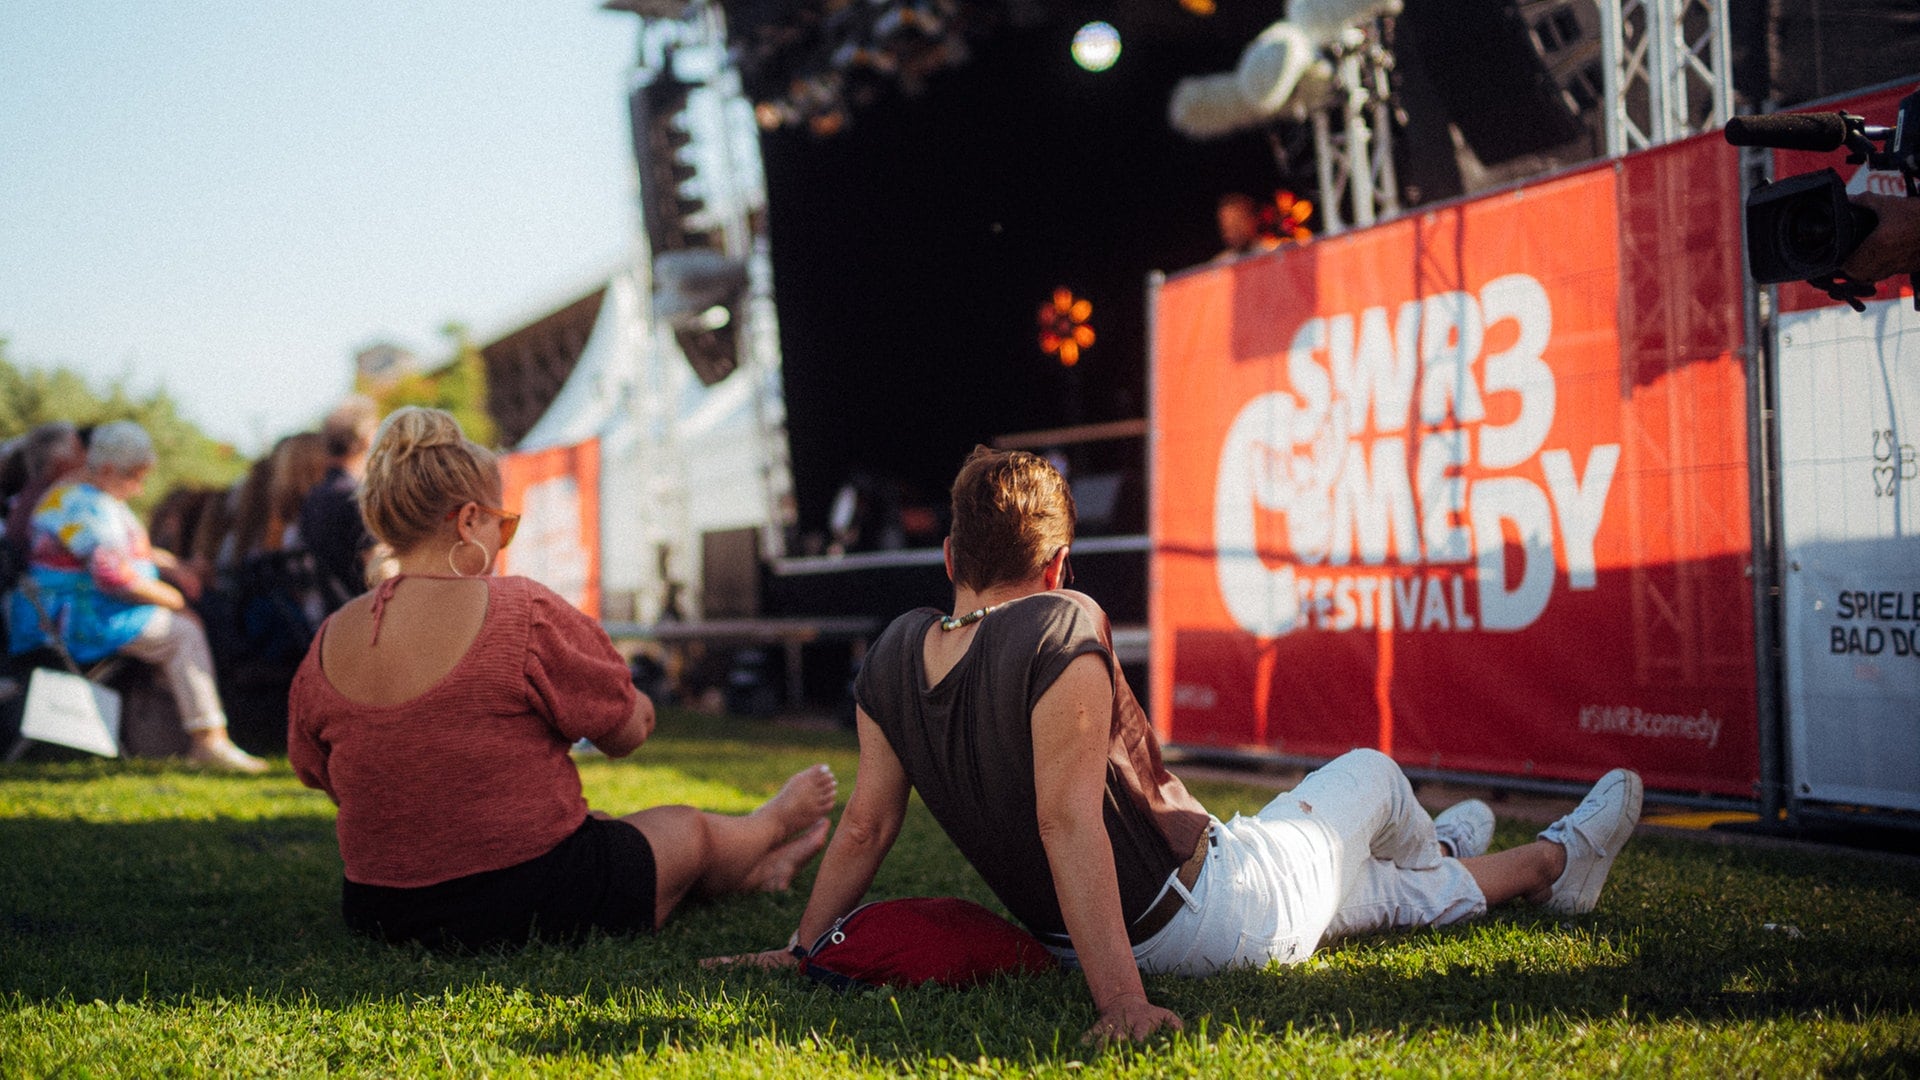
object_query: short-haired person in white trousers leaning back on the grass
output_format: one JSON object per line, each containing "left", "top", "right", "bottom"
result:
{"left": 714, "top": 448, "right": 1640, "bottom": 1040}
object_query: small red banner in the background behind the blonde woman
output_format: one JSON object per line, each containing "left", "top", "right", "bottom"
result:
{"left": 499, "top": 438, "right": 599, "bottom": 619}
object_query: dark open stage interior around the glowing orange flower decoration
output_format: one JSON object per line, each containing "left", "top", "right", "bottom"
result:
{"left": 762, "top": 15, "right": 1281, "bottom": 534}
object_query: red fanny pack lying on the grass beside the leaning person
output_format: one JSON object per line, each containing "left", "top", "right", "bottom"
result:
{"left": 804, "top": 896, "right": 1058, "bottom": 990}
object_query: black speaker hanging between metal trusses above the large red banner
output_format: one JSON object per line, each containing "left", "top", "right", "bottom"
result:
{"left": 1402, "top": 0, "right": 1603, "bottom": 165}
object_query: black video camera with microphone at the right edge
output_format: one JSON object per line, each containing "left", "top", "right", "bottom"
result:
{"left": 1726, "top": 92, "right": 1920, "bottom": 311}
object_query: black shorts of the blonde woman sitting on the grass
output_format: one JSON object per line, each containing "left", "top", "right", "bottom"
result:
{"left": 340, "top": 817, "right": 657, "bottom": 949}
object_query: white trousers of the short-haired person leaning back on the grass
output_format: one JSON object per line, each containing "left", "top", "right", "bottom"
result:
{"left": 1133, "top": 749, "right": 1486, "bottom": 974}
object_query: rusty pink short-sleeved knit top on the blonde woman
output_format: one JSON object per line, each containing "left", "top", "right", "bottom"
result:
{"left": 286, "top": 577, "right": 636, "bottom": 888}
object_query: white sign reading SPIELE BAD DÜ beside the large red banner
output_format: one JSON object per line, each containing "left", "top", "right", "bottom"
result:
{"left": 1776, "top": 298, "right": 1920, "bottom": 809}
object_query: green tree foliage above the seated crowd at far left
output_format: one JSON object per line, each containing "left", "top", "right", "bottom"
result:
{"left": 0, "top": 338, "right": 248, "bottom": 517}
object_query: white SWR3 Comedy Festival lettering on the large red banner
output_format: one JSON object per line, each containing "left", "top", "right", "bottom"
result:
{"left": 1213, "top": 273, "right": 1620, "bottom": 636}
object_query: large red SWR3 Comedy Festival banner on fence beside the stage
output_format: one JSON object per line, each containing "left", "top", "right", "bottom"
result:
{"left": 1150, "top": 136, "right": 1759, "bottom": 796}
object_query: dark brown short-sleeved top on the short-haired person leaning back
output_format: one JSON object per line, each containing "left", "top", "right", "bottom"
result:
{"left": 854, "top": 590, "right": 1210, "bottom": 934}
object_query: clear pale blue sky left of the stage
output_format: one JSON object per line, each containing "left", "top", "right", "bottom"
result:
{"left": 0, "top": 0, "right": 637, "bottom": 452}
